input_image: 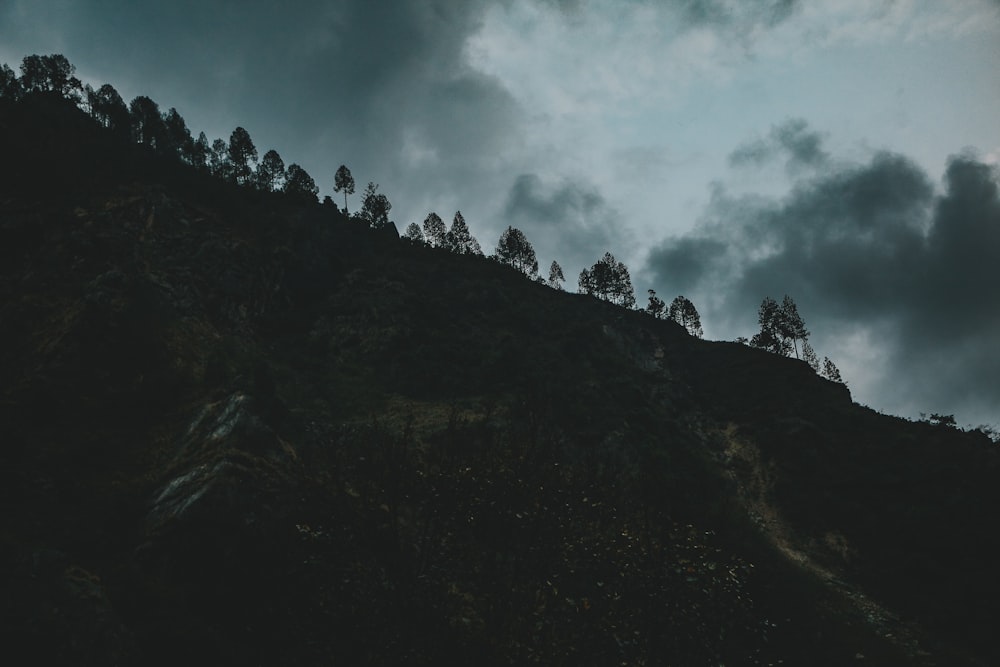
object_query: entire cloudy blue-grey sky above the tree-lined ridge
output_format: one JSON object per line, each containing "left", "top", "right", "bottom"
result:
{"left": 0, "top": 0, "right": 1000, "bottom": 426}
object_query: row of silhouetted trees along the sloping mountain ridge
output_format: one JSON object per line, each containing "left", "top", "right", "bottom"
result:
{"left": 0, "top": 54, "right": 846, "bottom": 384}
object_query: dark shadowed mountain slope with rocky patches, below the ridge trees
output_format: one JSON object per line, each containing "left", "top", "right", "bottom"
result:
{"left": 0, "top": 95, "right": 1000, "bottom": 665}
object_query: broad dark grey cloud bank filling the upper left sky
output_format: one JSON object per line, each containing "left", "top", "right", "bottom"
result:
{"left": 0, "top": 0, "right": 520, "bottom": 217}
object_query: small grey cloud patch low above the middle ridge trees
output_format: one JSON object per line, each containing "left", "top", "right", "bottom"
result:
{"left": 503, "top": 174, "right": 627, "bottom": 276}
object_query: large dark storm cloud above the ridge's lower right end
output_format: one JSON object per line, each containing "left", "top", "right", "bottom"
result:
{"left": 647, "top": 153, "right": 1000, "bottom": 422}
